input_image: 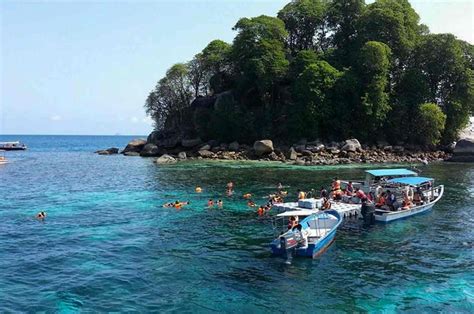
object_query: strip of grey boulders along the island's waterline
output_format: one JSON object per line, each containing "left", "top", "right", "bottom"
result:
{"left": 96, "top": 137, "right": 452, "bottom": 166}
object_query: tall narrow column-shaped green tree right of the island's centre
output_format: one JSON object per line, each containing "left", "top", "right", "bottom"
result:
{"left": 356, "top": 41, "right": 391, "bottom": 140}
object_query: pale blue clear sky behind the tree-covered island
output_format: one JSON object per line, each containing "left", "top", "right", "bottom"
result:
{"left": 0, "top": 0, "right": 474, "bottom": 135}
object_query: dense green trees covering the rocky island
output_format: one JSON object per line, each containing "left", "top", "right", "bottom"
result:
{"left": 145, "top": 0, "right": 474, "bottom": 146}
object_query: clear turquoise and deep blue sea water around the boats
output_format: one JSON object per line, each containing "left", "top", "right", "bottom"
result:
{"left": 0, "top": 136, "right": 474, "bottom": 313}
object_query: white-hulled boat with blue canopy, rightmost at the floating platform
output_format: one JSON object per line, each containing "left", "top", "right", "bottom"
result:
{"left": 375, "top": 177, "right": 444, "bottom": 223}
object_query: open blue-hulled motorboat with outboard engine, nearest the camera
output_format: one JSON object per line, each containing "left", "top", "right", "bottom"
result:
{"left": 271, "top": 210, "right": 343, "bottom": 261}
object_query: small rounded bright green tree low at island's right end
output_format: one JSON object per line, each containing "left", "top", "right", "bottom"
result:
{"left": 416, "top": 103, "right": 446, "bottom": 146}
